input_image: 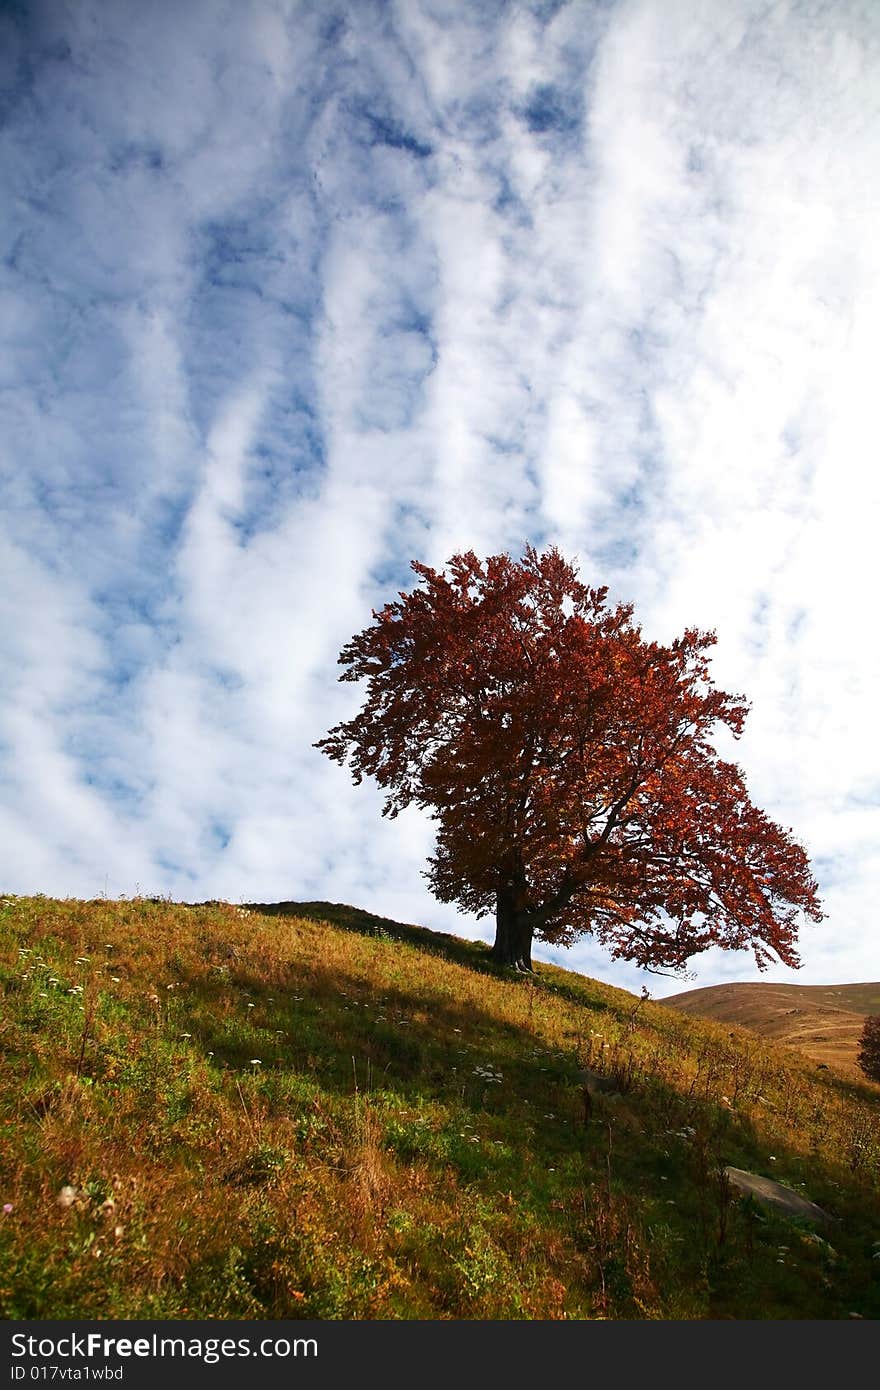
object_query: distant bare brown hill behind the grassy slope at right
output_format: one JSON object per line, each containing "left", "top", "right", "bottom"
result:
{"left": 662, "top": 981, "right": 880, "bottom": 1076}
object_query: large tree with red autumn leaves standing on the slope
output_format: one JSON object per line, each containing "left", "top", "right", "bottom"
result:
{"left": 314, "top": 546, "right": 823, "bottom": 970}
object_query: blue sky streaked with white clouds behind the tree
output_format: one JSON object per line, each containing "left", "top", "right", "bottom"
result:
{"left": 0, "top": 0, "right": 880, "bottom": 997}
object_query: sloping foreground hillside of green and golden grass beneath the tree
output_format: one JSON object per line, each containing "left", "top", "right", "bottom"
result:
{"left": 0, "top": 898, "right": 880, "bottom": 1319}
